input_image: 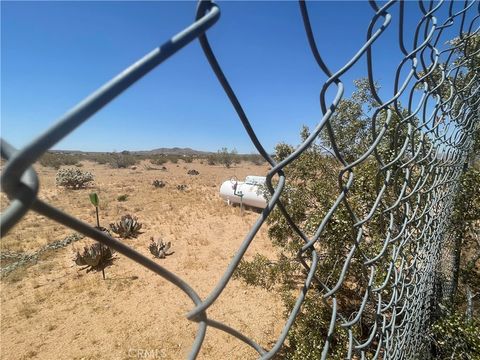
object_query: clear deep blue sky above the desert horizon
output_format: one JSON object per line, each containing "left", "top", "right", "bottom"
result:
{"left": 1, "top": 1, "right": 472, "bottom": 153}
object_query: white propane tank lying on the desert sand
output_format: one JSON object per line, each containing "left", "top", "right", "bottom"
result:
{"left": 220, "top": 176, "right": 267, "bottom": 209}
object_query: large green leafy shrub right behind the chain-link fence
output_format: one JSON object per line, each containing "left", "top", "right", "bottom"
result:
{"left": 235, "top": 79, "right": 403, "bottom": 360}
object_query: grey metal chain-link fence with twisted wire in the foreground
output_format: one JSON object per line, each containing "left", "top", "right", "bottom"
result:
{"left": 1, "top": 1, "right": 480, "bottom": 359}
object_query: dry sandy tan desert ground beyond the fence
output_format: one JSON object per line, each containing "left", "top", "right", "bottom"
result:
{"left": 0, "top": 160, "right": 283, "bottom": 359}
